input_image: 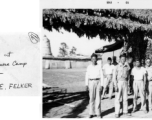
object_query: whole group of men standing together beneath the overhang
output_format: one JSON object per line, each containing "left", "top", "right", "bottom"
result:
{"left": 85, "top": 54, "right": 152, "bottom": 118}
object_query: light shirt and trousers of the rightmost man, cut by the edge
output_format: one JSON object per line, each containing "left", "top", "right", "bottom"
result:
{"left": 146, "top": 66, "right": 152, "bottom": 110}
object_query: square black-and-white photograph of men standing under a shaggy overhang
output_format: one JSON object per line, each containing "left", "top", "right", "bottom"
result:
{"left": 42, "top": 8, "right": 152, "bottom": 118}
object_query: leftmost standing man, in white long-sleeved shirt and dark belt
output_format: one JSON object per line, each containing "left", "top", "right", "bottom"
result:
{"left": 85, "top": 54, "right": 103, "bottom": 118}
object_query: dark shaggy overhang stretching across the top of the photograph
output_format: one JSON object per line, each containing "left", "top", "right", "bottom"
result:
{"left": 43, "top": 9, "right": 152, "bottom": 41}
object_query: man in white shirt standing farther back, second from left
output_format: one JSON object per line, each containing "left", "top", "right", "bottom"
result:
{"left": 102, "top": 57, "right": 114, "bottom": 99}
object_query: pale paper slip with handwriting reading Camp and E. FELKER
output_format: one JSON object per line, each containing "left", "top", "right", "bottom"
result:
{"left": 0, "top": 33, "right": 40, "bottom": 96}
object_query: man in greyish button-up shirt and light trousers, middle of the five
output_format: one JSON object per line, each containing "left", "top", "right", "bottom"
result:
{"left": 113, "top": 54, "right": 130, "bottom": 118}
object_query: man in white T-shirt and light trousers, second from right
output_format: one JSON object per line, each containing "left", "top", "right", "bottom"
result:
{"left": 131, "top": 59, "right": 147, "bottom": 113}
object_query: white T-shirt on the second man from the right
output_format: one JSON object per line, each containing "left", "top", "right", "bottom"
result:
{"left": 131, "top": 67, "right": 146, "bottom": 80}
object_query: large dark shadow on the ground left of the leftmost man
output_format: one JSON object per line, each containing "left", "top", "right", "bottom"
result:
{"left": 43, "top": 91, "right": 89, "bottom": 118}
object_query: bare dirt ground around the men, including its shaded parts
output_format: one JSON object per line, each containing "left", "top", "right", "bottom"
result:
{"left": 43, "top": 69, "right": 152, "bottom": 118}
